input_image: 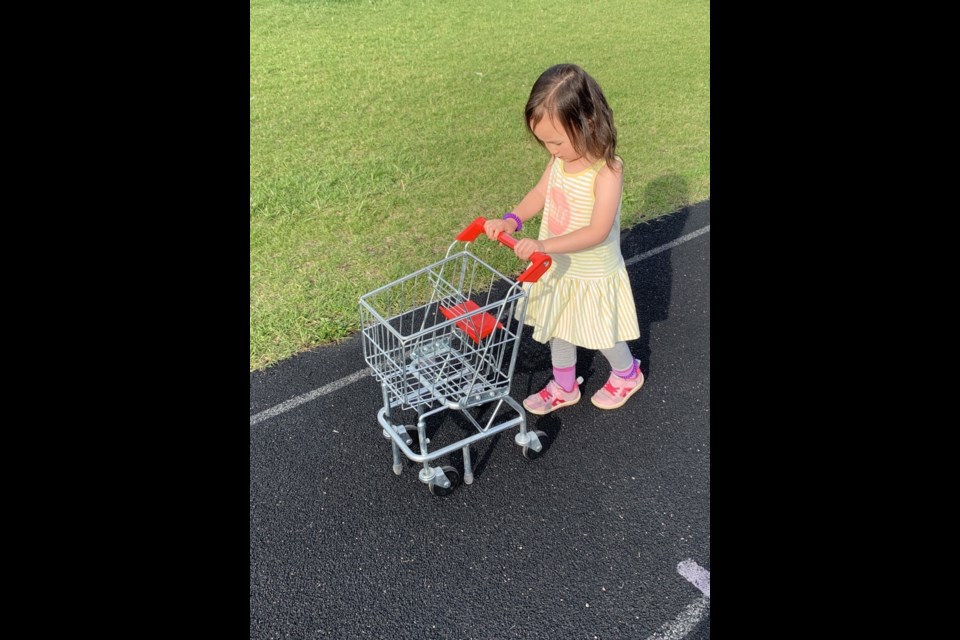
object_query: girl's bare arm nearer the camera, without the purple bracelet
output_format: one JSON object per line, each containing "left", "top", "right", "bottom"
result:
{"left": 513, "top": 165, "right": 623, "bottom": 260}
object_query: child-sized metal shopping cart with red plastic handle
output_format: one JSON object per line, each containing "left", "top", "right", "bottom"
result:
{"left": 360, "top": 217, "right": 551, "bottom": 495}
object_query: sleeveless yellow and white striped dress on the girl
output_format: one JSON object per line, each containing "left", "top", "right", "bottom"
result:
{"left": 524, "top": 159, "right": 640, "bottom": 349}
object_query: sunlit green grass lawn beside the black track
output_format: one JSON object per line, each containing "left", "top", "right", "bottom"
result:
{"left": 250, "top": 0, "right": 710, "bottom": 371}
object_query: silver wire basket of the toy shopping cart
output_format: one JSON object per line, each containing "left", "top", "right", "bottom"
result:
{"left": 360, "top": 251, "right": 526, "bottom": 409}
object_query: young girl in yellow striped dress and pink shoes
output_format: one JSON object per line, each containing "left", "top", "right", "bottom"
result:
{"left": 484, "top": 64, "right": 644, "bottom": 415}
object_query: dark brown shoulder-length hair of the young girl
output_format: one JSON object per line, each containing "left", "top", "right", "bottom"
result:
{"left": 524, "top": 64, "right": 617, "bottom": 166}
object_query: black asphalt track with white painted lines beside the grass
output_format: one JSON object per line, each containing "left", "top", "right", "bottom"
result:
{"left": 250, "top": 200, "right": 710, "bottom": 640}
